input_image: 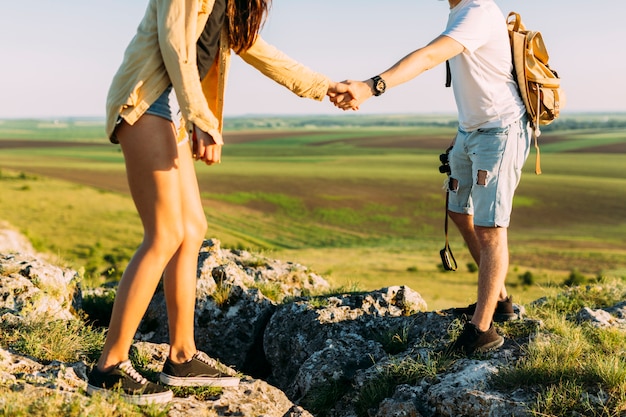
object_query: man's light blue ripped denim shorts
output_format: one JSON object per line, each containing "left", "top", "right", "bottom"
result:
{"left": 448, "top": 116, "right": 531, "bottom": 227}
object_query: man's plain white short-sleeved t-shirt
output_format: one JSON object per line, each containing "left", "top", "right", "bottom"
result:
{"left": 443, "top": 0, "right": 526, "bottom": 132}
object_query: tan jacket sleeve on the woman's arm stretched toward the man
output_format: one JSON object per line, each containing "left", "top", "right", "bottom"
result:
{"left": 239, "top": 36, "right": 329, "bottom": 101}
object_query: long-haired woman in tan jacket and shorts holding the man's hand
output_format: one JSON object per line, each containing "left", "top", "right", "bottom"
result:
{"left": 87, "top": 0, "right": 335, "bottom": 404}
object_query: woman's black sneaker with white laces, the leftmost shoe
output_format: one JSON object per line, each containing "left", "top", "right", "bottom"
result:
{"left": 87, "top": 360, "right": 174, "bottom": 405}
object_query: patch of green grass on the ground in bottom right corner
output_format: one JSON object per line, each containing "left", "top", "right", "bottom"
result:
{"left": 492, "top": 280, "right": 626, "bottom": 417}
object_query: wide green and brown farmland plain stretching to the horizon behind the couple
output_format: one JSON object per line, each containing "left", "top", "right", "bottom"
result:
{"left": 0, "top": 115, "right": 626, "bottom": 309}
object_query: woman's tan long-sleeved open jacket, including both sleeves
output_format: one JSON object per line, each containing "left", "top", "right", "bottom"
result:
{"left": 106, "top": 0, "right": 329, "bottom": 144}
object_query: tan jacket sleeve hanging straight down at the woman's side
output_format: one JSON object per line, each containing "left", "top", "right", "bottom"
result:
{"left": 157, "top": 0, "right": 221, "bottom": 144}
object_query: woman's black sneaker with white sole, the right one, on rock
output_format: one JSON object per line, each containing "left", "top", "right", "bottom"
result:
{"left": 160, "top": 351, "right": 239, "bottom": 388}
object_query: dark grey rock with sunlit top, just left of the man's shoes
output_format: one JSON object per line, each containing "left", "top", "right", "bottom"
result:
{"left": 263, "top": 287, "right": 426, "bottom": 395}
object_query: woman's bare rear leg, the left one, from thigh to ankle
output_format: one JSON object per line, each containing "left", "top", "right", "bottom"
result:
{"left": 98, "top": 115, "right": 195, "bottom": 370}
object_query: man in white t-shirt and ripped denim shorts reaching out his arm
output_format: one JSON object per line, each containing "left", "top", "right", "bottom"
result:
{"left": 331, "top": 0, "right": 530, "bottom": 355}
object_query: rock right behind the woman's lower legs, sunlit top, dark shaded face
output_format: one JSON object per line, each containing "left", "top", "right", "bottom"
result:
{"left": 137, "top": 239, "right": 329, "bottom": 378}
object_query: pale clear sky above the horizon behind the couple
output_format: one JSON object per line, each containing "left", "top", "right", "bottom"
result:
{"left": 0, "top": 0, "right": 626, "bottom": 119}
